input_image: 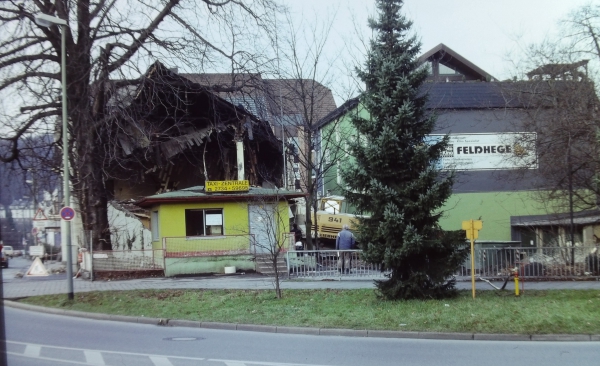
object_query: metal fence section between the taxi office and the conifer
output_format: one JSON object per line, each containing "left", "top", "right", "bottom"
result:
{"left": 284, "top": 250, "right": 386, "bottom": 279}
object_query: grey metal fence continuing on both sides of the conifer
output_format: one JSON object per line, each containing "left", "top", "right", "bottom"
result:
{"left": 283, "top": 247, "right": 600, "bottom": 281}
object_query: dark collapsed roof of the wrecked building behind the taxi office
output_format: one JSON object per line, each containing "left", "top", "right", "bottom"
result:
{"left": 107, "top": 62, "right": 282, "bottom": 192}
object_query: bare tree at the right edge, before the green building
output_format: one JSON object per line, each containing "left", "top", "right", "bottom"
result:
{"left": 504, "top": 5, "right": 600, "bottom": 261}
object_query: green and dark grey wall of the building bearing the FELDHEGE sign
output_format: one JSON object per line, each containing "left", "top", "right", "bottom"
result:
{"left": 323, "top": 101, "right": 576, "bottom": 241}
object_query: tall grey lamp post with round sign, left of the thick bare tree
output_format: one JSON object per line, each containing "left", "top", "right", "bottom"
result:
{"left": 35, "top": 14, "right": 74, "bottom": 300}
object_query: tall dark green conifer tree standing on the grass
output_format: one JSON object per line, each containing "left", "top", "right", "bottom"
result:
{"left": 342, "top": 0, "right": 467, "bottom": 299}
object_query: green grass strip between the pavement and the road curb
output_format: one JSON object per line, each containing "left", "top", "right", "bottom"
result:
{"left": 21, "top": 289, "right": 600, "bottom": 334}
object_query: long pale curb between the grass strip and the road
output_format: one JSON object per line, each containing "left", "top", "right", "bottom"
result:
{"left": 4, "top": 300, "right": 600, "bottom": 342}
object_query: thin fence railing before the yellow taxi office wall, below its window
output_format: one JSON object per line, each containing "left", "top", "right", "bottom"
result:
{"left": 163, "top": 235, "right": 254, "bottom": 258}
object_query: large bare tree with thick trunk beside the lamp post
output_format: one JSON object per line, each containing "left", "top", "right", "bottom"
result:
{"left": 0, "top": 0, "right": 277, "bottom": 250}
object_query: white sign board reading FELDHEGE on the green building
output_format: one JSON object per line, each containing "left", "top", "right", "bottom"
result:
{"left": 429, "top": 132, "right": 537, "bottom": 170}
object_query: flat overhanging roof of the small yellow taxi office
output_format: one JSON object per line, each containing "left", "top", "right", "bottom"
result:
{"left": 137, "top": 186, "right": 306, "bottom": 207}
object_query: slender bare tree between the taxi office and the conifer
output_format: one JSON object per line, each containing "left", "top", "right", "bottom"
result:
{"left": 268, "top": 9, "right": 350, "bottom": 249}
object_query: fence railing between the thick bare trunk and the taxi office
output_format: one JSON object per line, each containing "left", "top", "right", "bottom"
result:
{"left": 89, "top": 249, "right": 164, "bottom": 272}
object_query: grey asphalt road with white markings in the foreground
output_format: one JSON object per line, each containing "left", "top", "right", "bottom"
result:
{"left": 4, "top": 307, "right": 600, "bottom": 366}
